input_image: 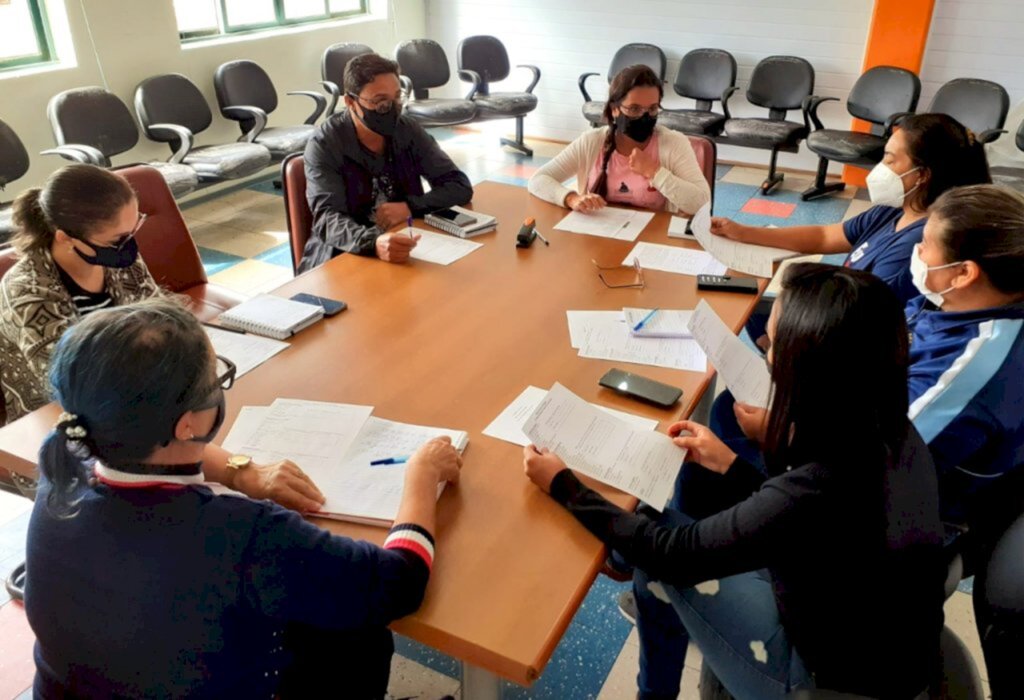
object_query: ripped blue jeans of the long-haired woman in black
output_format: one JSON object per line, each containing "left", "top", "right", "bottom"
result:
{"left": 633, "top": 510, "right": 814, "bottom": 700}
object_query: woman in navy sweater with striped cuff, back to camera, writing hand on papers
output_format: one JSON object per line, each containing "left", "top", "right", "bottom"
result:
{"left": 25, "top": 300, "right": 461, "bottom": 698}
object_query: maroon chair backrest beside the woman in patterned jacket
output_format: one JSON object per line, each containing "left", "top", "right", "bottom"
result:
{"left": 118, "top": 166, "right": 207, "bottom": 292}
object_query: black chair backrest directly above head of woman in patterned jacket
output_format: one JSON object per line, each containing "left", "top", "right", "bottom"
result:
{"left": 46, "top": 87, "right": 138, "bottom": 158}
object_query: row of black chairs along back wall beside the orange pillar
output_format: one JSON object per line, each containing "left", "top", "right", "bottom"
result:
{"left": 579, "top": 43, "right": 1024, "bottom": 200}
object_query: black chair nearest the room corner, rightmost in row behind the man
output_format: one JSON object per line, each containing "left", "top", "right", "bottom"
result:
{"left": 459, "top": 35, "right": 541, "bottom": 156}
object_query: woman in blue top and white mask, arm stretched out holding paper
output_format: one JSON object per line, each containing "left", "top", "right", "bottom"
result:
{"left": 712, "top": 115, "right": 992, "bottom": 304}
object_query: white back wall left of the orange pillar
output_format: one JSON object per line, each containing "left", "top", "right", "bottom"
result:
{"left": 427, "top": 0, "right": 872, "bottom": 170}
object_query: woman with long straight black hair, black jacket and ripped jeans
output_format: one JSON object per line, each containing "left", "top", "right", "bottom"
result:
{"left": 524, "top": 264, "right": 945, "bottom": 700}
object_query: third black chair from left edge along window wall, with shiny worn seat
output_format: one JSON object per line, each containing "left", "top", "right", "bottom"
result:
{"left": 135, "top": 73, "right": 270, "bottom": 182}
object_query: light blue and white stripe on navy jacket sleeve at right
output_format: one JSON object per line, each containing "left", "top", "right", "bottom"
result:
{"left": 910, "top": 318, "right": 1024, "bottom": 443}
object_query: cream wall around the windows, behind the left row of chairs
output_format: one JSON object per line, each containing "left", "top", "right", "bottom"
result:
{"left": 0, "top": 0, "right": 426, "bottom": 190}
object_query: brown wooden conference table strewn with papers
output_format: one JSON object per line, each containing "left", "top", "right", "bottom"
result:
{"left": 0, "top": 182, "right": 757, "bottom": 698}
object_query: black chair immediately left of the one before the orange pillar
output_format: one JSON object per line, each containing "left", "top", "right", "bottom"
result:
{"left": 715, "top": 56, "right": 814, "bottom": 194}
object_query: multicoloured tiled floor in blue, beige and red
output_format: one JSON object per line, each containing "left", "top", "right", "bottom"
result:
{"left": 0, "top": 129, "right": 986, "bottom": 700}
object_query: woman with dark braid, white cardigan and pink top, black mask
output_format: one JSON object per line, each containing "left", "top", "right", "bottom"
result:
{"left": 529, "top": 65, "right": 711, "bottom": 214}
